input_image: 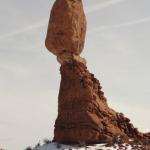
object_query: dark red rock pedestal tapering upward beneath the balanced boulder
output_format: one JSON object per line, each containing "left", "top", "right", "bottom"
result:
{"left": 54, "top": 61, "right": 143, "bottom": 143}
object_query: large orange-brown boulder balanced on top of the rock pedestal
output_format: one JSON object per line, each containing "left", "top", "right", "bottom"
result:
{"left": 45, "top": 0, "right": 86, "bottom": 57}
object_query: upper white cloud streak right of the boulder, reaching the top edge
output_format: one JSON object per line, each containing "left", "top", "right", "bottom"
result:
{"left": 85, "top": 0, "right": 125, "bottom": 13}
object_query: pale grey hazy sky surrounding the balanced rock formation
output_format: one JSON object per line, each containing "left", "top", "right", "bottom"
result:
{"left": 0, "top": 0, "right": 150, "bottom": 150}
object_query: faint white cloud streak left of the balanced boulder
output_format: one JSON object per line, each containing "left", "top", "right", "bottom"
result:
{"left": 0, "top": 19, "right": 47, "bottom": 40}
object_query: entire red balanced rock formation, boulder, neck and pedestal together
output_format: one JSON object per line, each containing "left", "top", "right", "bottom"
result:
{"left": 45, "top": 0, "right": 150, "bottom": 148}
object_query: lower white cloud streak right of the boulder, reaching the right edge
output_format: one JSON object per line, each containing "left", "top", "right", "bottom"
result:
{"left": 88, "top": 17, "right": 150, "bottom": 34}
